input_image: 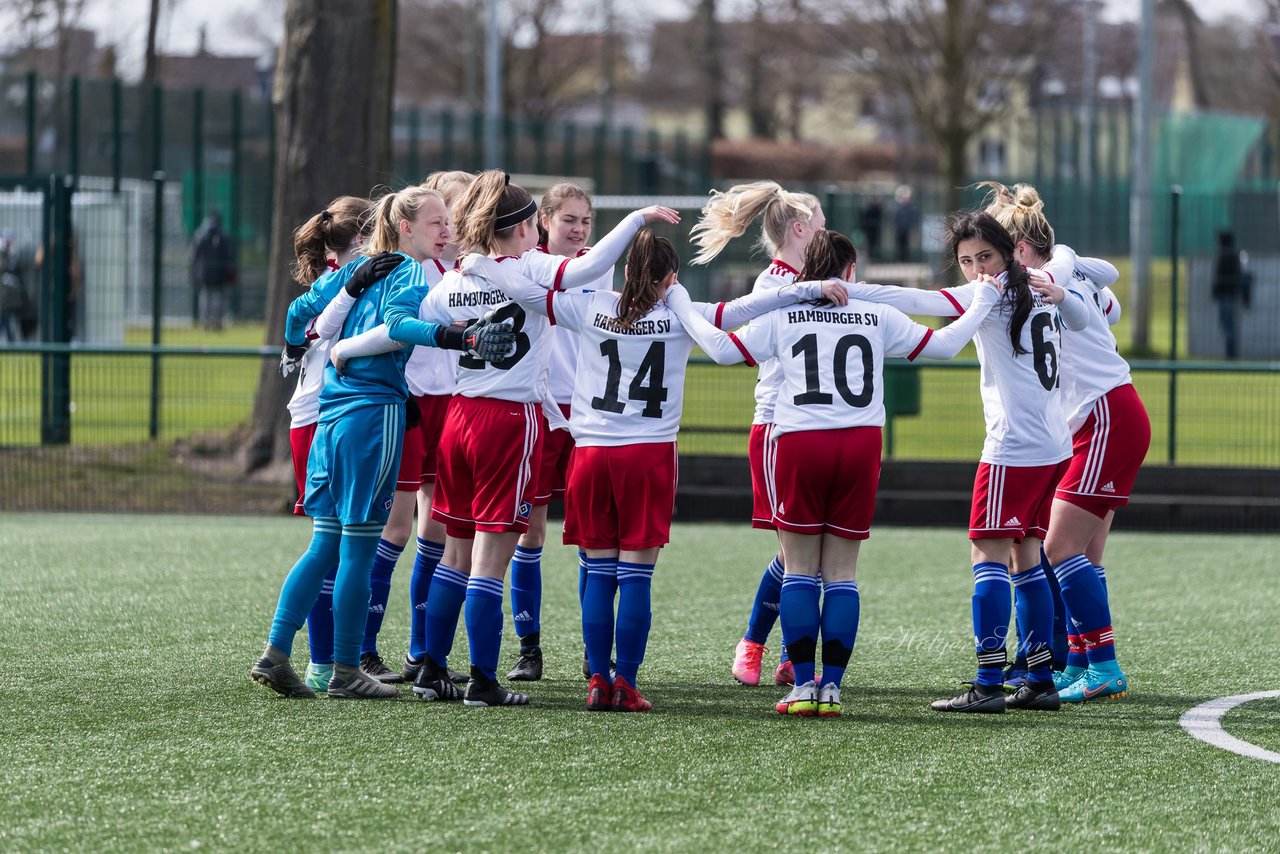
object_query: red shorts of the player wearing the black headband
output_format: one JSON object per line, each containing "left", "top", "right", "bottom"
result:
{"left": 431, "top": 394, "right": 543, "bottom": 539}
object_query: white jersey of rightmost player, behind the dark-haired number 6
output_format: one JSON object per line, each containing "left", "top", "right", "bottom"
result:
{"left": 1062, "top": 269, "right": 1133, "bottom": 435}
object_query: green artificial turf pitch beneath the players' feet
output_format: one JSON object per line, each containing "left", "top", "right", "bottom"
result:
{"left": 0, "top": 515, "right": 1280, "bottom": 851}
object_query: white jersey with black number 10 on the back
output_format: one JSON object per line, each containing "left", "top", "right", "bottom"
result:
{"left": 732, "top": 300, "right": 932, "bottom": 440}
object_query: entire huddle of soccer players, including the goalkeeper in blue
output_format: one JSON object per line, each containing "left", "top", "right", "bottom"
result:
{"left": 250, "top": 170, "right": 1149, "bottom": 717}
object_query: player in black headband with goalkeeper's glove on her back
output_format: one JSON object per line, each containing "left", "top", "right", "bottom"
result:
{"left": 332, "top": 170, "right": 680, "bottom": 705}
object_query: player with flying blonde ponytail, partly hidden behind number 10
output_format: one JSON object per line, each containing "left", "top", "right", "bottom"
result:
{"left": 691, "top": 181, "right": 827, "bottom": 685}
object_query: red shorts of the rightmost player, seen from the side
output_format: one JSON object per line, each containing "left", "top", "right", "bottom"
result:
{"left": 1055, "top": 383, "right": 1151, "bottom": 517}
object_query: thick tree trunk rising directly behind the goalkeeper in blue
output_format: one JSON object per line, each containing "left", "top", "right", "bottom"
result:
{"left": 241, "top": 0, "right": 396, "bottom": 471}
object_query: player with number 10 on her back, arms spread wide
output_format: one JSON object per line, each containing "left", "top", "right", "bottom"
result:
{"left": 672, "top": 230, "right": 1000, "bottom": 717}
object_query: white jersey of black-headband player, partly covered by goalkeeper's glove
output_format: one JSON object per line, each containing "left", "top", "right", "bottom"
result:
{"left": 419, "top": 257, "right": 553, "bottom": 403}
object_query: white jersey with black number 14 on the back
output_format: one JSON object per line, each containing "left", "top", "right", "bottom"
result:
{"left": 547, "top": 291, "right": 696, "bottom": 446}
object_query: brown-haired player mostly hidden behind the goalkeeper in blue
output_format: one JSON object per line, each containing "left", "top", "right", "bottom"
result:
{"left": 280, "top": 196, "right": 373, "bottom": 691}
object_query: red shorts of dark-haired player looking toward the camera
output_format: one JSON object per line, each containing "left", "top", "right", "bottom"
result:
{"left": 969, "top": 460, "right": 1068, "bottom": 540}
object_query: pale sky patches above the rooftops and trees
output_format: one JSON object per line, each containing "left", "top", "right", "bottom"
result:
{"left": 5, "top": 0, "right": 1262, "bottom": 77}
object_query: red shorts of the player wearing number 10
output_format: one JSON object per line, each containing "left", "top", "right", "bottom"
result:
{"left": 773, "top": 426, "right": 881, "bottom": 540}
